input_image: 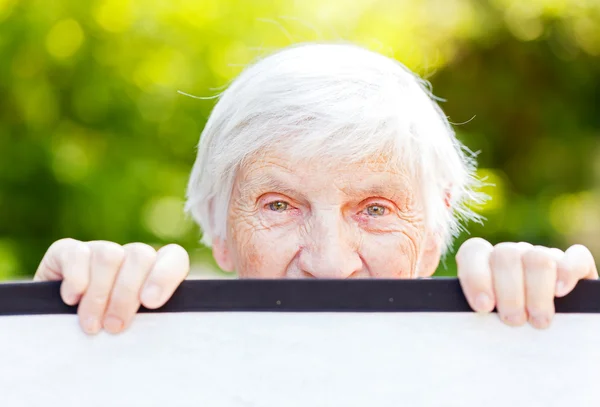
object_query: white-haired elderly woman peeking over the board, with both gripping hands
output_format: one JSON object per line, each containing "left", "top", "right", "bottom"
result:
{"left": 34, "top": 44, "right": 598, "bottom": 334}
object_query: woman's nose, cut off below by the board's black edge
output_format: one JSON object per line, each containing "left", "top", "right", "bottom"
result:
{"left": 298, "top": 213, "right": 363, "bottom": 279}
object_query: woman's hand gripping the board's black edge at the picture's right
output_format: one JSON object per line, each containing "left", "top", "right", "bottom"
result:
{"left": 456, "top": 238, "right": 598, "bottom": 329}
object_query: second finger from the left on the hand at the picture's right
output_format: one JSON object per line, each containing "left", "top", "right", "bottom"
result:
{"left": 490, "top": 243, "right": 531, "bottom": 326}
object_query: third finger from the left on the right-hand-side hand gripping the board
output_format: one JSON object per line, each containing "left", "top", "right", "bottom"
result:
{"left": 523, "top": 248, "right": 557, "bottom": 329}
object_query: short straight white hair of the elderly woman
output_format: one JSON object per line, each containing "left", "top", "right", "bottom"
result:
{"left": 186, "top": 43, "right": 481, "bottom": 253}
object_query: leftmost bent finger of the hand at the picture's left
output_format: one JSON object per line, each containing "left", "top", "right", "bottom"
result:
{"left": 33, "top": 239, "right": 91, "bottom": 305}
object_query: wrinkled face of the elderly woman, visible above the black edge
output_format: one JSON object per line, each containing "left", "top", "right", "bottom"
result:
{"left": 213, "top": 152, "right": 441, "bottom": 278}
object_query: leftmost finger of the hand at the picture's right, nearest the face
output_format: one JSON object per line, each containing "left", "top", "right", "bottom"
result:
{"left": 456, "top": 238, "right": 496, "bottom": 312}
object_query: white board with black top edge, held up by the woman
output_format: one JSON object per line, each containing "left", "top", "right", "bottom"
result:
{"left": 0, "top": 282, "right": 600, "bottom": 407}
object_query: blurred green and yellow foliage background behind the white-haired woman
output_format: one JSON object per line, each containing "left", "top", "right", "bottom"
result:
{"left": 0, "top": 0, "right": 600, "bottom": 280}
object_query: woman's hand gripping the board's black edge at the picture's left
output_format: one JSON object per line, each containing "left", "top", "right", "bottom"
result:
{"left": 34, "top": 239, "right": 190, "bottom": 334}
